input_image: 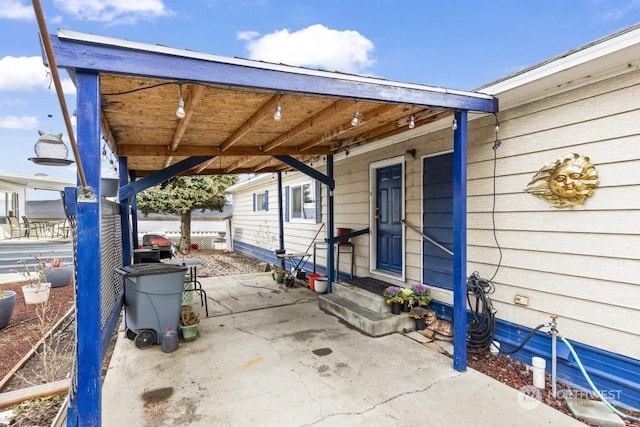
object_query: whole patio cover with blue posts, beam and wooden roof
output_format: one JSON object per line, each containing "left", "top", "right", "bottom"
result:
{"left": 44, "top": 31, "right": 498, "bottom": 425}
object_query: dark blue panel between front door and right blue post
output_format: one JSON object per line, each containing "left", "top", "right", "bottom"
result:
{"left": 422, "top": 153, "right": 453, "bottom": 289}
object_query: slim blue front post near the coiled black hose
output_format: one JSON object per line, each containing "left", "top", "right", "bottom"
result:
{"left": 453, "top": 111, "right": 467, "bottom": 371}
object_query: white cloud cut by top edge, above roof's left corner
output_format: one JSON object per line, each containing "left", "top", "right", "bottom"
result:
{"left": 54, "top": 0, "right": 171, "bottom": 25}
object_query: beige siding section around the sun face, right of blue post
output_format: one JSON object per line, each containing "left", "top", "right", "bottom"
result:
{"left": 467, "top": 68, "right": 640, "bottom": 359}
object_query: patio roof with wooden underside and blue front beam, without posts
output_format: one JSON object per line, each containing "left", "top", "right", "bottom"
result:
{"left": 51, "top": 30, "right": 498, "bottom": 177}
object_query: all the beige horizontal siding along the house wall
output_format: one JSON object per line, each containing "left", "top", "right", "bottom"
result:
{"left": 234, "top": 67, "right": 640, "bottom": 359}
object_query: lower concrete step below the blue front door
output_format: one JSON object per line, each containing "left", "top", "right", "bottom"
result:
{"left": 318, "top": 294, "right": 415, "bottom": 337}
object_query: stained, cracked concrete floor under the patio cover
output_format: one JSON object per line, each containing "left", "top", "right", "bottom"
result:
{"left": 102, "top": 273, "right": 584, "bottom": 427}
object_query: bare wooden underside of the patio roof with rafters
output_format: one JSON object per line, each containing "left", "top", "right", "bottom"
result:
{"left": 100, "top": 74, "right": 452, "bottom": 176}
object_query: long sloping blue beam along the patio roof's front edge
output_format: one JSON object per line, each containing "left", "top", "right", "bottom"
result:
{"left": 50, "top": 35, "right": 498, "bottom": 113}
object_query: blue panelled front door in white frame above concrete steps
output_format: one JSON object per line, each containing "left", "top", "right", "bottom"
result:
{"left": 376, "top": 164, "right": 403, "bottom": 273}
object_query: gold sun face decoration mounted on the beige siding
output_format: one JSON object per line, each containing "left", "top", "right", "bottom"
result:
{"left": 525, "top": 153, "right": 600, "bottom": 209}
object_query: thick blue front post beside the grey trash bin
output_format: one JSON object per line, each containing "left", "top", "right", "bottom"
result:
{"left": 67, "top": 72, "right": 102, "bottom": 426}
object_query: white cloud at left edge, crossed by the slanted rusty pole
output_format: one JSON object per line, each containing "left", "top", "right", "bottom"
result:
{"left": 0, "top": 56, "right": 76, "bottom": 95}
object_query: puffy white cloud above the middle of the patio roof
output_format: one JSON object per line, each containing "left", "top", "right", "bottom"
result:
{"left": 237, "top": 24, "right": 375, "bottom": 74}
